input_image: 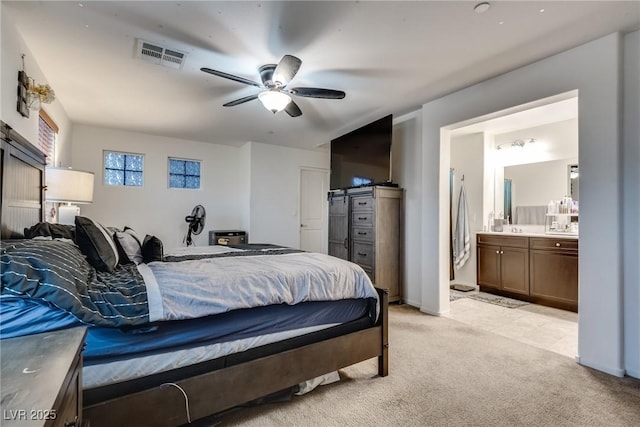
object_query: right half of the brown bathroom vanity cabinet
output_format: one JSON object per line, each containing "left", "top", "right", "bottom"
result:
{"left": 529, "top": 237, "right": 578, "bottom": 311}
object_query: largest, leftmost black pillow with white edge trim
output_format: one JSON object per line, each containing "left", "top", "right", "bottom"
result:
{"left": 76, "top": 216, "right": 119, "bottom": 273}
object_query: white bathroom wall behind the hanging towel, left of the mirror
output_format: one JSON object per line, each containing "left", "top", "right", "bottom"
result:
{"left": 451, "top": 133, "right": 486, "bottom": 286}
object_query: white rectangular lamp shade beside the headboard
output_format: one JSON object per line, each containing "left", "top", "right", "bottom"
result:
{"left": 45, "top": 168, "right": 93, "bottom": 203}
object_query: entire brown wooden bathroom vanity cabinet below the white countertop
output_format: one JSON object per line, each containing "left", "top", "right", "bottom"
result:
{"left": 476, "top": 234, "right": 578, "bottom": 311}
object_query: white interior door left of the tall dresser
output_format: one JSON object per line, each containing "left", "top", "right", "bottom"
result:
{"left": 300, "top": 169, "right": 329, "bottom": 253}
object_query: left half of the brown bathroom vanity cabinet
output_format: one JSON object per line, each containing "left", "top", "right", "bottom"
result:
{"left": 477, "top": 235, "right": 529, "bottom": 295}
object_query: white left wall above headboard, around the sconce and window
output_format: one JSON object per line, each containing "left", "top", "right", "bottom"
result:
{"left": 0, "top": 4, "right": 71, "bottom": 166}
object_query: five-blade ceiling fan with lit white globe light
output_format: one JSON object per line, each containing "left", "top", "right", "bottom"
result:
{"left": 200, "top": 55, "right": 345, "bottom": 117}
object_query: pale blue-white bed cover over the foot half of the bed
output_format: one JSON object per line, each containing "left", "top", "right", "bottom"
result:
{"left": 138, "top": 248, "right": 379, "bottom": 322}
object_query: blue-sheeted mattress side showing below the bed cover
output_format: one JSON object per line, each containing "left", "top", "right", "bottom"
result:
{"left": 0, "top": 297, "right": 375, "bottom": 366}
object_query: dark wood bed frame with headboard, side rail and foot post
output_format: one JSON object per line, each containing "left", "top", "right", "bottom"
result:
{"left": 0, "top": 123, "right": 389, "bottom": 427}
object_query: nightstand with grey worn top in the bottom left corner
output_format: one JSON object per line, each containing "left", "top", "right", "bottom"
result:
{"left": 0, "top": 327, "right": 87, "bottom": 427}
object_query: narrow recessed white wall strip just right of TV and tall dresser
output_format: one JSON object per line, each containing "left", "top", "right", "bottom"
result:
{"left": 391, "top": 113, "right": 422, "bottom": 307}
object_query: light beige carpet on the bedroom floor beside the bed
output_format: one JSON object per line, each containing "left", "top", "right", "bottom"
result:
{"left": 220, "top": 305, "right": 640, "bottom": 427}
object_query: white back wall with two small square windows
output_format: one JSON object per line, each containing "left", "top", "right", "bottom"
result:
{"left": 72, "top": 125, "right": 249, "bottom": 249}
